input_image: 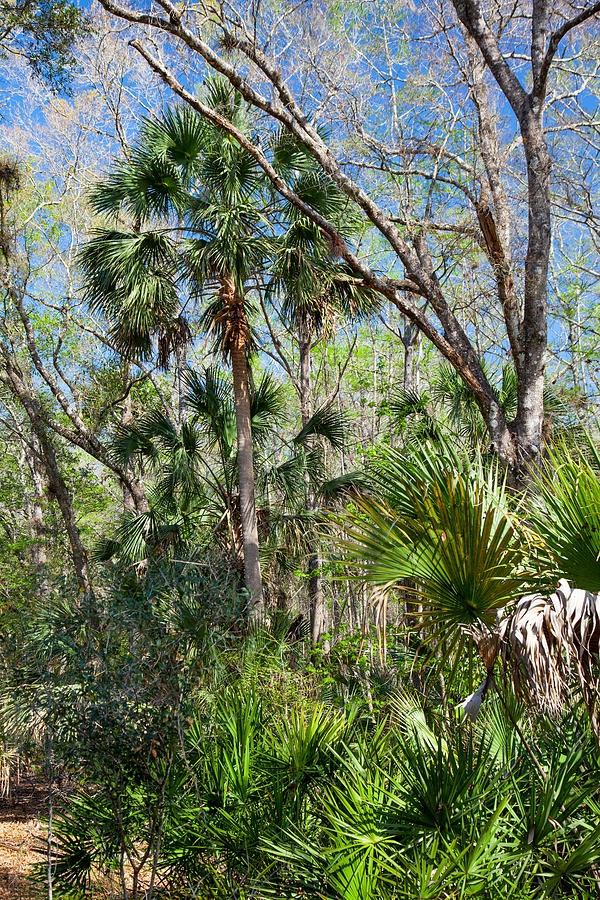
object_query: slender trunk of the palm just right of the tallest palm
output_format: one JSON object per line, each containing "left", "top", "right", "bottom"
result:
{"left": 298, "top": 322, "right": 327, "bottom": 647}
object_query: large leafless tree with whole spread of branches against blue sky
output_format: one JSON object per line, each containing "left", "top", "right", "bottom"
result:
{"left": 92, "top": 0, "right": 600, "bottom": 480}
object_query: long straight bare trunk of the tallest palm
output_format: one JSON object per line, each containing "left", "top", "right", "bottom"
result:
{"left": 230, "top": 338, "right": 265, "bottom": 622}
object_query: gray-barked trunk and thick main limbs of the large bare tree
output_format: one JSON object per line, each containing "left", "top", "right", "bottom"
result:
{"left": 100, "top": 0, "right": 600, "bottom": 483}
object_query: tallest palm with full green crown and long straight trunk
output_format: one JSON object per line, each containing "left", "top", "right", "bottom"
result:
{"left": 81, "top": 81, "right": 270, "bottom": 619}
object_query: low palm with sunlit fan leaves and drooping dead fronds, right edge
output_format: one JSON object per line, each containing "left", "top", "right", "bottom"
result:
{"left": 344, "top": 438, "right": 600, "bottom": 746}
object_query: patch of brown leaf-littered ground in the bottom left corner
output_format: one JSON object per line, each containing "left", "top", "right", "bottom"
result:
{"left": 0, "top": 775, "right": 47, "bottom": 900}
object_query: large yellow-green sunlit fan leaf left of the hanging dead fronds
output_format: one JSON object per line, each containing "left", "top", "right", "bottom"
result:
{"left": 347, "top": 483, "right": 525, "bottom": 633}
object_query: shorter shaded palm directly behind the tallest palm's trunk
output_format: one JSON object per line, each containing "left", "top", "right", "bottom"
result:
{"left": 96, "top": 368, "right": 282, "bottom": 576}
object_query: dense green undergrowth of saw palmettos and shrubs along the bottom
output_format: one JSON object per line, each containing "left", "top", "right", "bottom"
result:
{"left": 5, "top": 566, "right": 600, "bottom": 900}
